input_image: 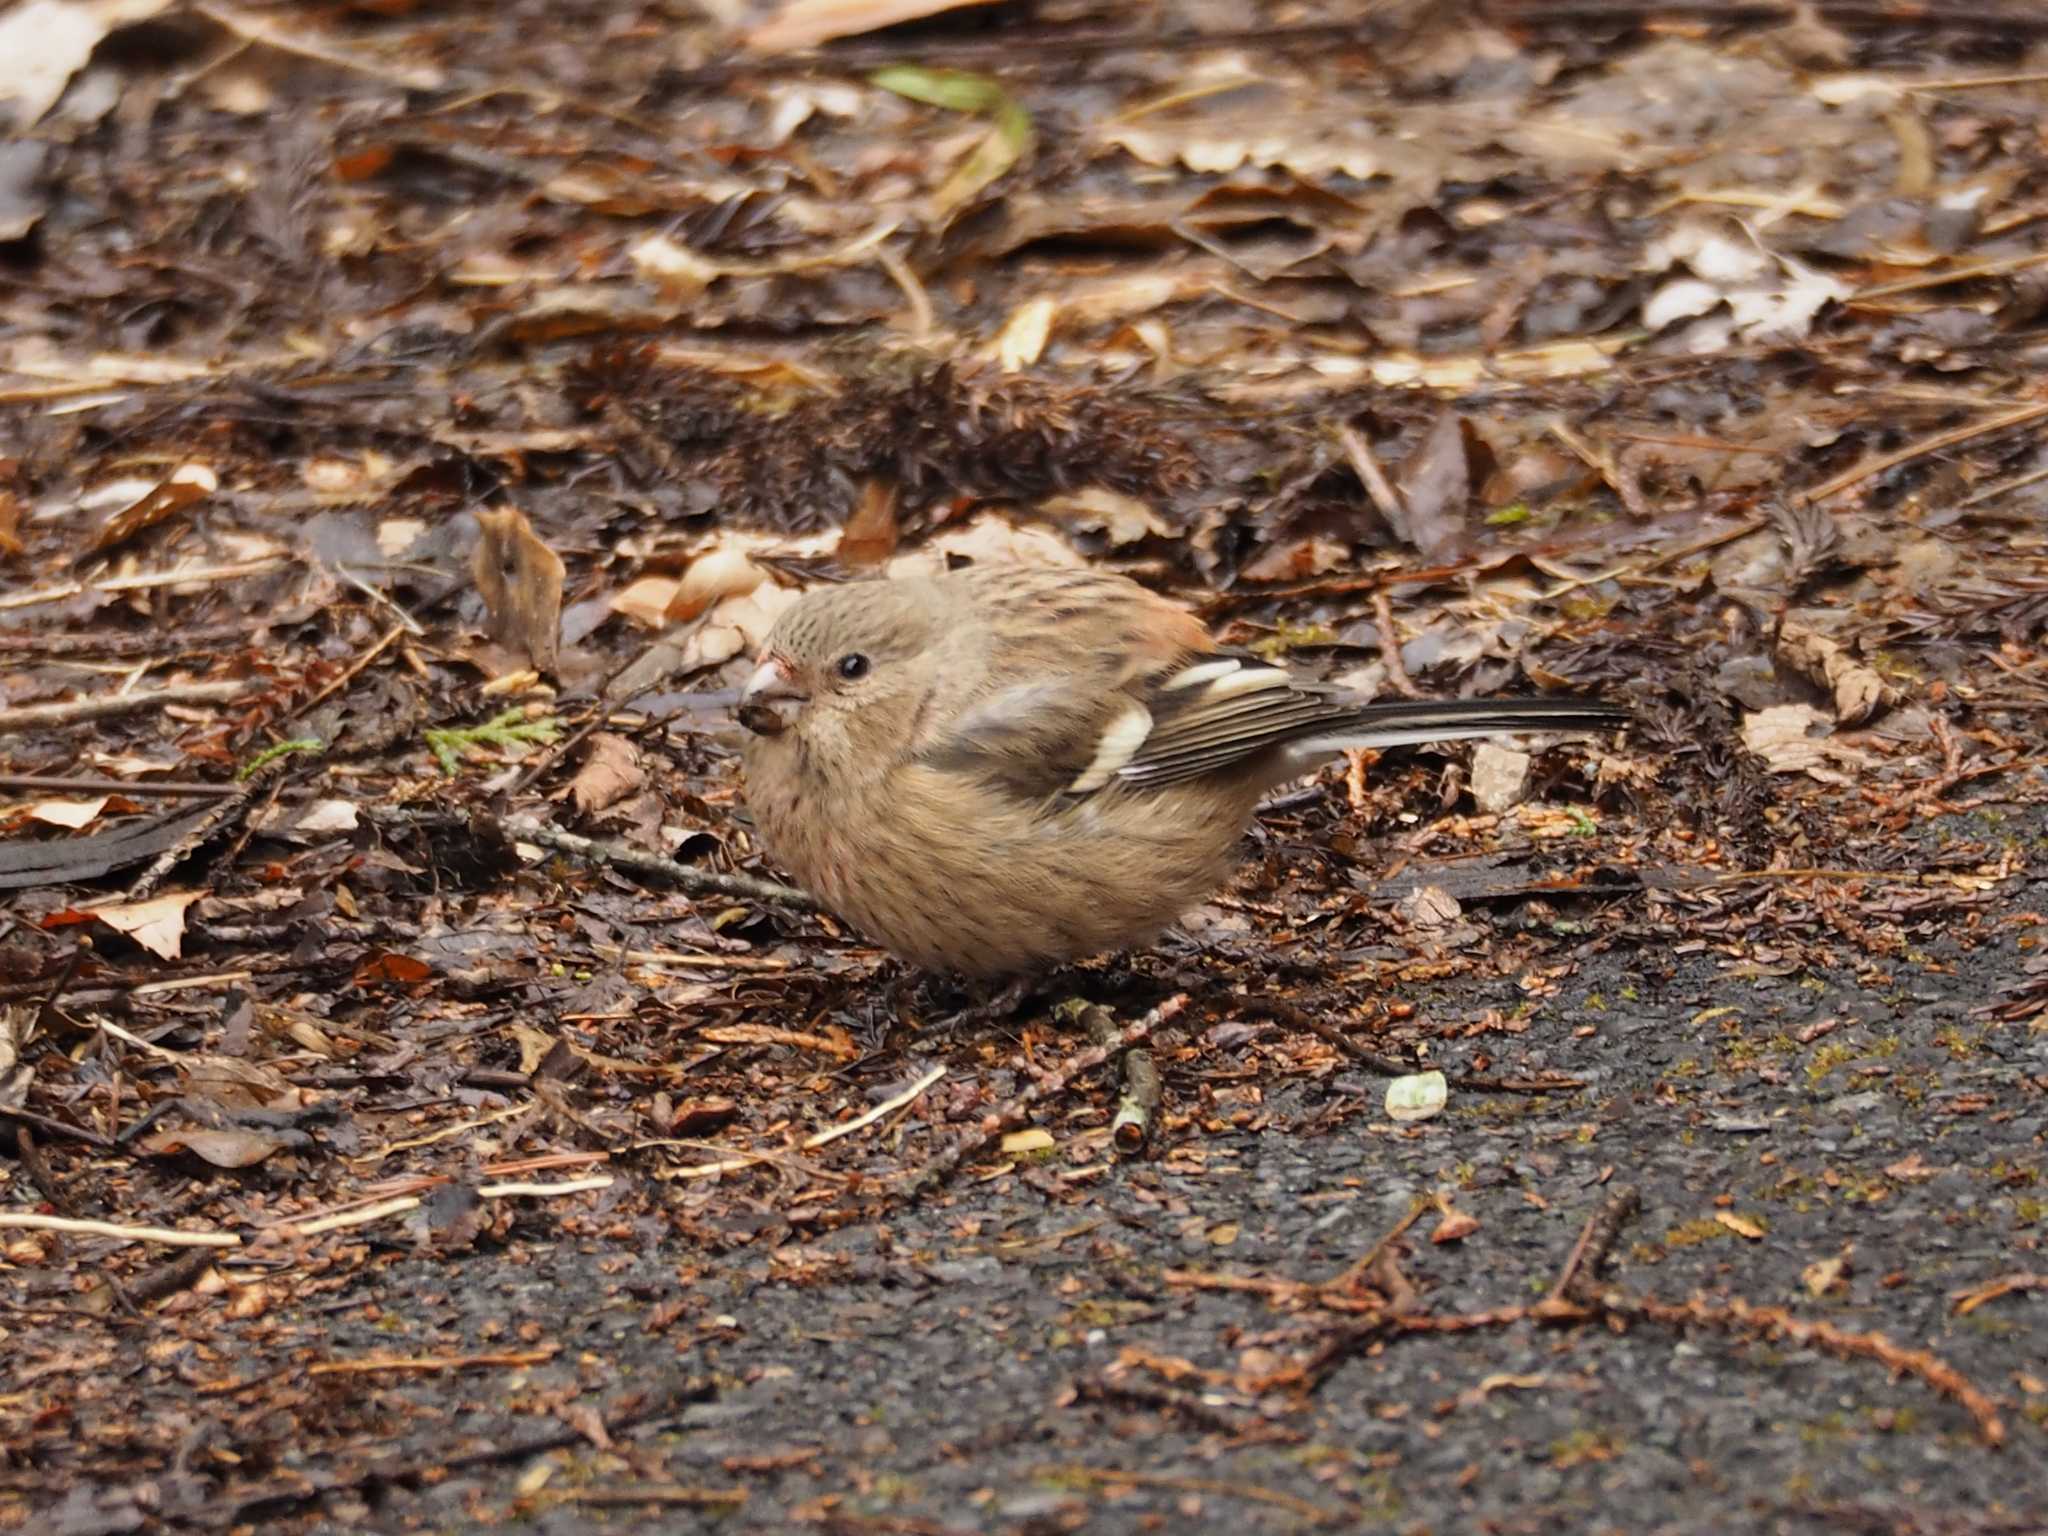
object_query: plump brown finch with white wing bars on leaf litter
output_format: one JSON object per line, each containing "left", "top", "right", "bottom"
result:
{"left": 739, "top": 565, "right": 1626, "bottom": 977}
